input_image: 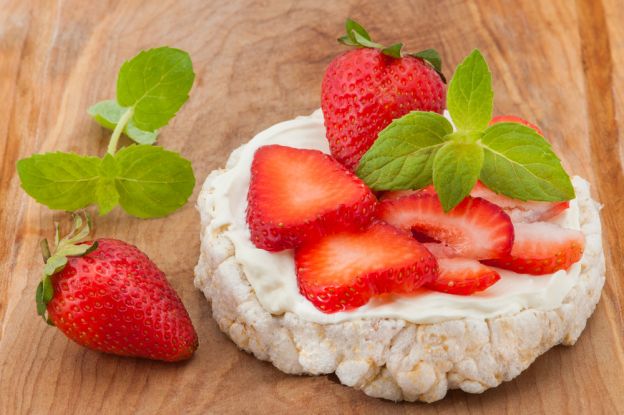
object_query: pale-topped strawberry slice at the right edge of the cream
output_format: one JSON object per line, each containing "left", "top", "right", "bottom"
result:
{"left": 484, "top": 222, "right": 585, "bottom": 275}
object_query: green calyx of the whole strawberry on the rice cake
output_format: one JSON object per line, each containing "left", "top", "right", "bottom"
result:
{"left": 338, "top": 19, "right": 446, "bottom": 83}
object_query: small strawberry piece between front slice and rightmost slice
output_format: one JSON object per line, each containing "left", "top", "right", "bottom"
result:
{"left": 426, "top": 258, "right": 500, "bottom": 295}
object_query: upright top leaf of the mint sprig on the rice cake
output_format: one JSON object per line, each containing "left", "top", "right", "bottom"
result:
{"left": 446, "top": 49, "right": 494, "bottom": 131}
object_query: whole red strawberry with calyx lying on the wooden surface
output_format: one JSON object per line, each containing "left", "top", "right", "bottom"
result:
{"left": 37, "top": 216, "right": 198, "bottom": 362}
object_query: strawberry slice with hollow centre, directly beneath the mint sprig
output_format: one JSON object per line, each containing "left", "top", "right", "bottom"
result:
{"left": 376, "top": 192, "right": 514, "bottom": 259}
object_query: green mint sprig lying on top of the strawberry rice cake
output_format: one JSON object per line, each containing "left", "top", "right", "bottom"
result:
{"left": 357, "top": 50, "right": 574, "bottom": 212}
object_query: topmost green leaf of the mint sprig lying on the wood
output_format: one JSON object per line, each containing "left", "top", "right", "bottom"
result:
{"left": 117, "top": 47, "right": 195, "bottom": 131}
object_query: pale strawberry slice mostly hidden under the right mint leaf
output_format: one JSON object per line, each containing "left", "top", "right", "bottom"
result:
{"left": 470, "top": 182, "right": 570, "bottom": 223}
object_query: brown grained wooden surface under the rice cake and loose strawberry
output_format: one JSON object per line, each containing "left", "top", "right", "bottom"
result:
{"left": 0, "top": 0, "right": 624, "bottom": 414}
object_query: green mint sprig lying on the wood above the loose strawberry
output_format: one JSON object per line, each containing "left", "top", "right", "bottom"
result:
{"left": 17, "top": 47, "right": 195, "bottom": 218}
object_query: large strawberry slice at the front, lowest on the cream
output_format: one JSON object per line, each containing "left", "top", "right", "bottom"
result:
{"left": 295, "top": 222, "right": 438, "bottom": 313}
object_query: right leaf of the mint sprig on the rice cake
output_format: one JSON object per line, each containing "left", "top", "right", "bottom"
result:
{"left": 480, "top": 123, "right": 574, "bottom": 202}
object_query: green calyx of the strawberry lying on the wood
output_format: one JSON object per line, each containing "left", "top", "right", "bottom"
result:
{"left": 35, "top": 212, "right": 98, "bottom": 325}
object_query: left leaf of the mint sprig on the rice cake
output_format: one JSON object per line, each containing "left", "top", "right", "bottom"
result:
{"left": 357, "top": 112, "right": 453, "bottom": 190}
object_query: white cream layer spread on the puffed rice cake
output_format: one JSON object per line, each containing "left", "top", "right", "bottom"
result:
{"left": 210, "top": 110, "right": 580, "bottom": 323}
